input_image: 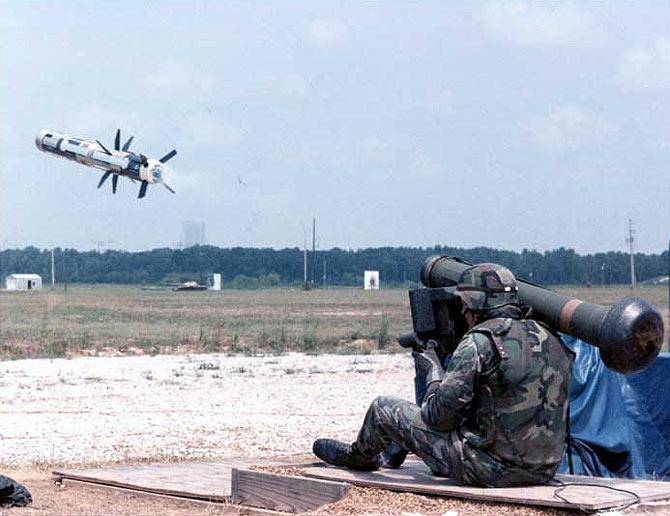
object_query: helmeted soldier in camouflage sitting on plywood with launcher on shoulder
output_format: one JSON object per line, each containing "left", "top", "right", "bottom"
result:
{"left": 313, "top": 264, "right": 573, "bottom": 487}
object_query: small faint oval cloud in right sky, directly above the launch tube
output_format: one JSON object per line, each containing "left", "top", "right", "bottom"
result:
{"left": 523, "top": 105, "right": 614, "bottom": 150}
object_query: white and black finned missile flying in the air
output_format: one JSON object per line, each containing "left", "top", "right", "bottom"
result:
{"left": 35, "top": 129, "right": 176, "bottom": 197}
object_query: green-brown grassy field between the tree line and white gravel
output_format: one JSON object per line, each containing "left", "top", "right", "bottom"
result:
{"left": 0, "top": 286, "right": 668, "bottom": 359}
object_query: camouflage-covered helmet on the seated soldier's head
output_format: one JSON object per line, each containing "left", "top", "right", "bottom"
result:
{"left": 456, "top": 263, "right": 519, "bottom": 311}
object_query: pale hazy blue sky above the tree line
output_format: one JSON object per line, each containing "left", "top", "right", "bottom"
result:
{"left": 0, "top": 0, "right": 670, "bottom": 253}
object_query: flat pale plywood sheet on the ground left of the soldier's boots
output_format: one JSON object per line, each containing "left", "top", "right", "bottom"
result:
{"left": 52, "top": 457, "right": 314, "bottom": 502}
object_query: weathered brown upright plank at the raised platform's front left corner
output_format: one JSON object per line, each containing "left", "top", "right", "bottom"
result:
{"left": 232, "top": 468, "right": 349, "bottom": 512}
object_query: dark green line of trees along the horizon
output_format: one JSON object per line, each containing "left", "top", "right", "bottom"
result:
{"left": 0, "top": 246, "right": 669, "bottom": 288}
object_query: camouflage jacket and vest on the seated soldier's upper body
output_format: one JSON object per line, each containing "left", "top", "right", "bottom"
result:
{"left": 421, "top": 318, "right": 573, "bottom": 476}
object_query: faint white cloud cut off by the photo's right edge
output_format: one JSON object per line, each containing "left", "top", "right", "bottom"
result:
{"left": 617, "top": 38, "right": 670, "bottom": 90}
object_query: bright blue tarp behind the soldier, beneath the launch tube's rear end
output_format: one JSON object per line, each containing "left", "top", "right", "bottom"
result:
{"left": 560, "top": 335, "right": 670, "bottom": 479}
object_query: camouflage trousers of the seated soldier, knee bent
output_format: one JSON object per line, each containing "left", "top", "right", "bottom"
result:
{"left": 353, "top": 396, "right": 553, "bottom": 487}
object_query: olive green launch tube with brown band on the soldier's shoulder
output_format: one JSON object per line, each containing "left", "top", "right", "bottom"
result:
{"left": 421, "top": 256, "right": 663, "bottom": 373}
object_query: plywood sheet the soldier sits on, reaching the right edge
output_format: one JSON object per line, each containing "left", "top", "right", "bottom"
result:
{"left": 303, "top": 460, "right": 670, "bottom": 511}
